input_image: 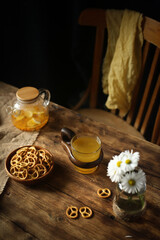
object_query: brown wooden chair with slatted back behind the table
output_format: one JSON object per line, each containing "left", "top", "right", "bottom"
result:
{"left": 73, "top": 9, "right": 160, "bottom": 145}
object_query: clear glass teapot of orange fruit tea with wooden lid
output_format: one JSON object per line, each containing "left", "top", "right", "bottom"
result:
{"left": 7, "top": 87, "right": 50, "bottom": 131}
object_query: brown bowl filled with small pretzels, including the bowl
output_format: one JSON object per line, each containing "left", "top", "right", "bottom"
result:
{"left": 5, "top": 146, "right": 54, "bottom": 184}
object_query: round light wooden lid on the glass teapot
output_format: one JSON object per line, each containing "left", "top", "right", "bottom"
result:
{"left": 16, "top": 87, "right": 39, "bottom": 101}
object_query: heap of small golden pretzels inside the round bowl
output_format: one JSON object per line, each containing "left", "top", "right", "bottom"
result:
{"left": 10, "top": 146, "right": 53, "bottom": 180}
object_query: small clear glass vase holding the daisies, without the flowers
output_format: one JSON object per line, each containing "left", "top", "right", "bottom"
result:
{"left": 113, "top": 183, "right": 146, "bottom": 221}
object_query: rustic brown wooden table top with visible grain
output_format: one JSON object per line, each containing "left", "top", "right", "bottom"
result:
{"left": 0, "top": 83, "right": 160, "bottom": 240}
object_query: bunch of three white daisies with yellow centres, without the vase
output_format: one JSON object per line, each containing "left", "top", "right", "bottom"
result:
{"left": 107, "top": 150, "right": 146, "bottom": 194}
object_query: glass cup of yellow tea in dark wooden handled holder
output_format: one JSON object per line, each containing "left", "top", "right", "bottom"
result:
{"left": 61, "top": 128, "right": 103, "bottom": 174}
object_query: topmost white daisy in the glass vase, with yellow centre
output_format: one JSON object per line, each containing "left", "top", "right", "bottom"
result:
{"left": 119, "top": 150, "right": 140, "bottom": 172}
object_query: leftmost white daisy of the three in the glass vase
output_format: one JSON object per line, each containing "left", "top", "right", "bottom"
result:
{"left": 107, "top": 155, "right": 124, "bottom": 182}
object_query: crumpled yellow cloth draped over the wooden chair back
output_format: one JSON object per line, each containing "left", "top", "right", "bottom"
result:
{"left": 102, "top": 9, "right": 143, "bottom": 115}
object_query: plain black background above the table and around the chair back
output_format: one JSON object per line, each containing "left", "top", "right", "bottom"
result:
{"left": 1, "top": 0, "right": 160, "bottom": 107}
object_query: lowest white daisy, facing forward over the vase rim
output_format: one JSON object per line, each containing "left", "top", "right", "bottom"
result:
{"left": 121, "top": 169, "right": 146, "bottom": 194}
